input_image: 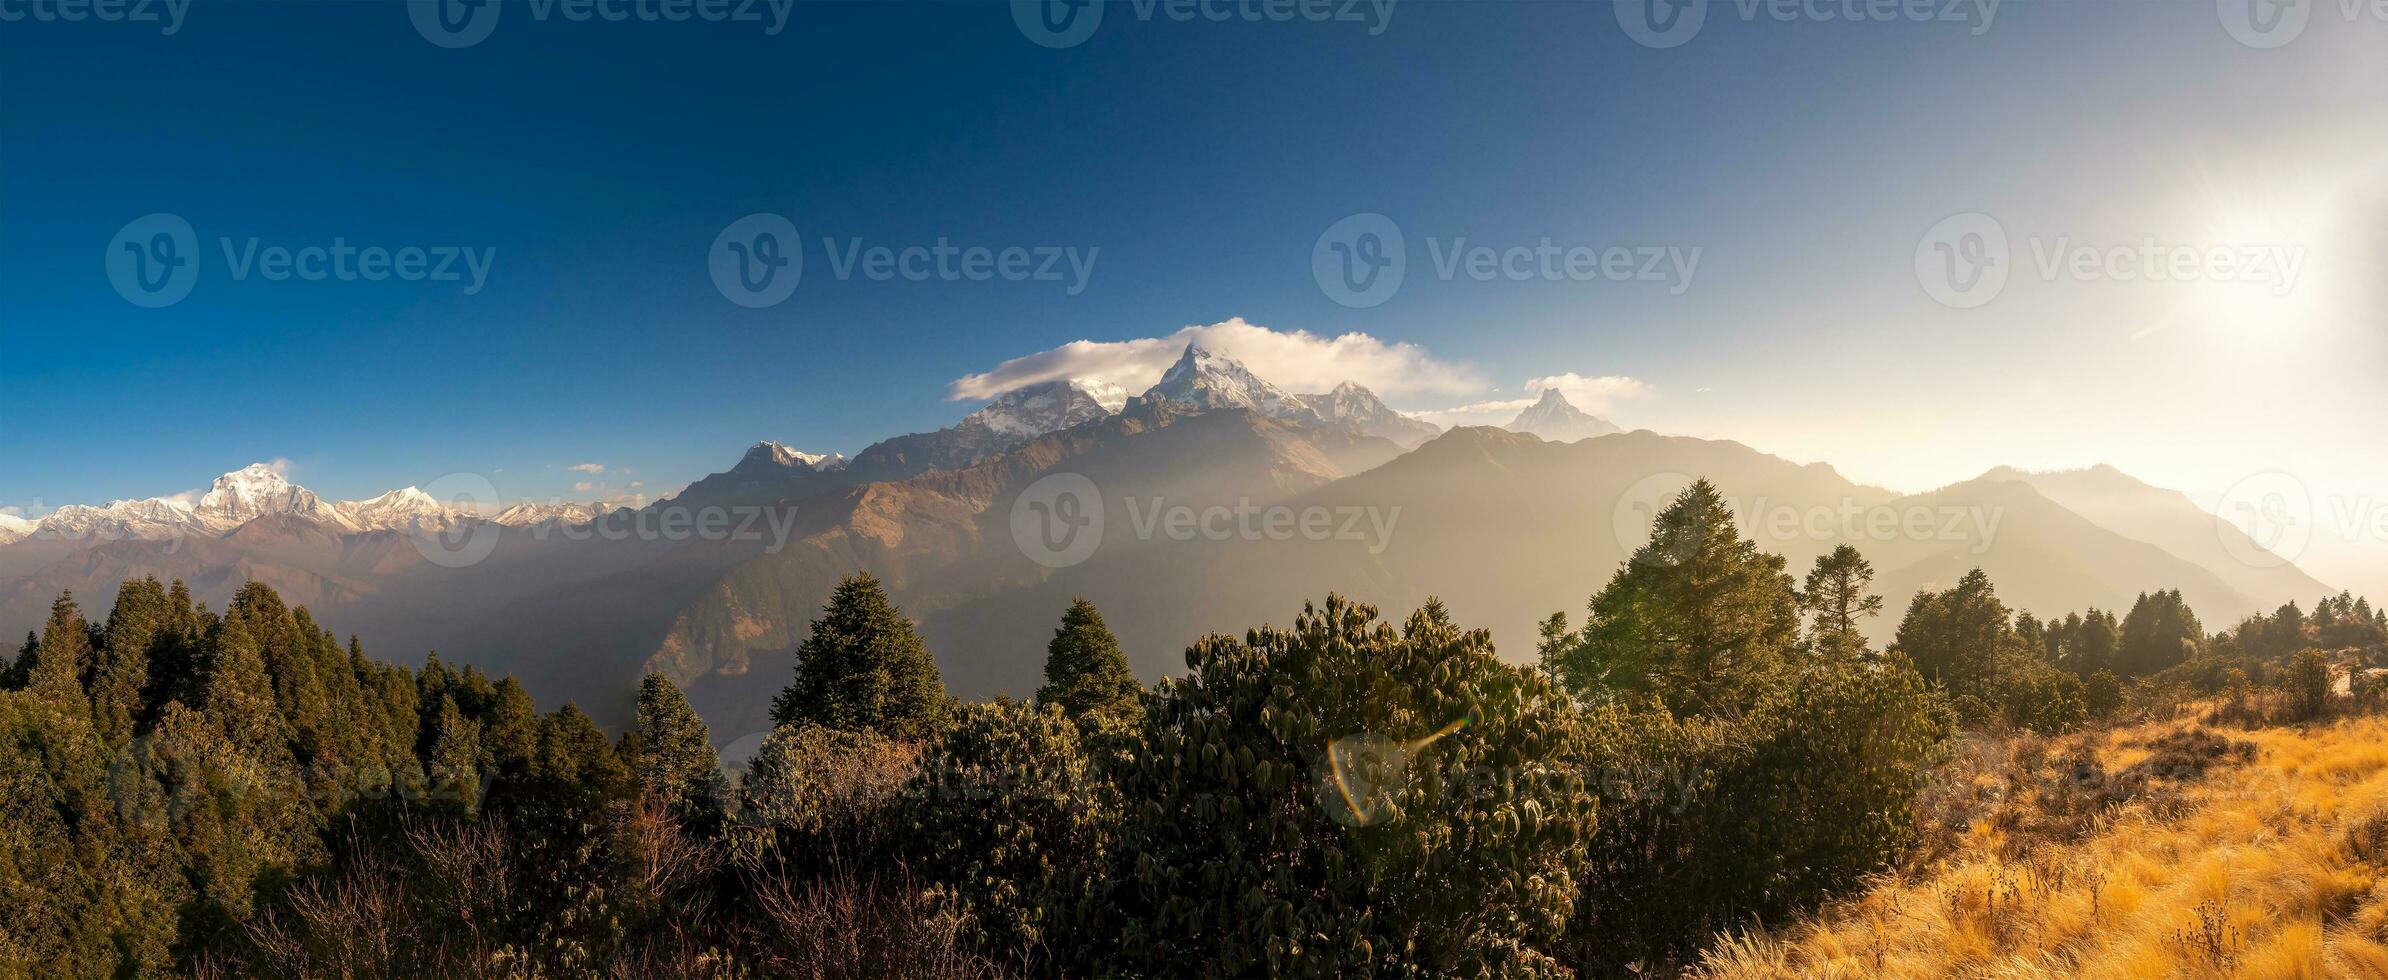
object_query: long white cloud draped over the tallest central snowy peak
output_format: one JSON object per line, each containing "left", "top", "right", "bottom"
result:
{"left": 946, "top": 318, "right": 1485, "bottom": 402}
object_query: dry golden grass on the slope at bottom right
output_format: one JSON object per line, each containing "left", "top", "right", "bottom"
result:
{"left": 1703, "top": 717, "right": 2388, "bottom": 980}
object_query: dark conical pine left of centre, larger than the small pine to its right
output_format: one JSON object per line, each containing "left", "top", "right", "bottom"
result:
{"left": 771, "top": 574, "right": 953, "bottom": 739}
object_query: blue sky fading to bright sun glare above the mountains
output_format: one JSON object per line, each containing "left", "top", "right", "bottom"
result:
{"left": 0, "top": 0, "right": 2388, "bottom": 590}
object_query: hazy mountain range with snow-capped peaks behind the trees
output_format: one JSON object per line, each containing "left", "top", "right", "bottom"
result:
{"left": 0, "top": 347, "right": 2326, "bottom": 743}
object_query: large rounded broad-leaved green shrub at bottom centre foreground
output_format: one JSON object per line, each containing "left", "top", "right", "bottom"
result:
{"left": 1075, "top": 598, "right": 1595, "bottom": 975}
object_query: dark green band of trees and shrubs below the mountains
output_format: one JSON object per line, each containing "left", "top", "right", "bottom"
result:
{"left": 0, "top": 480, "right": 2388, "bottom": 978}
